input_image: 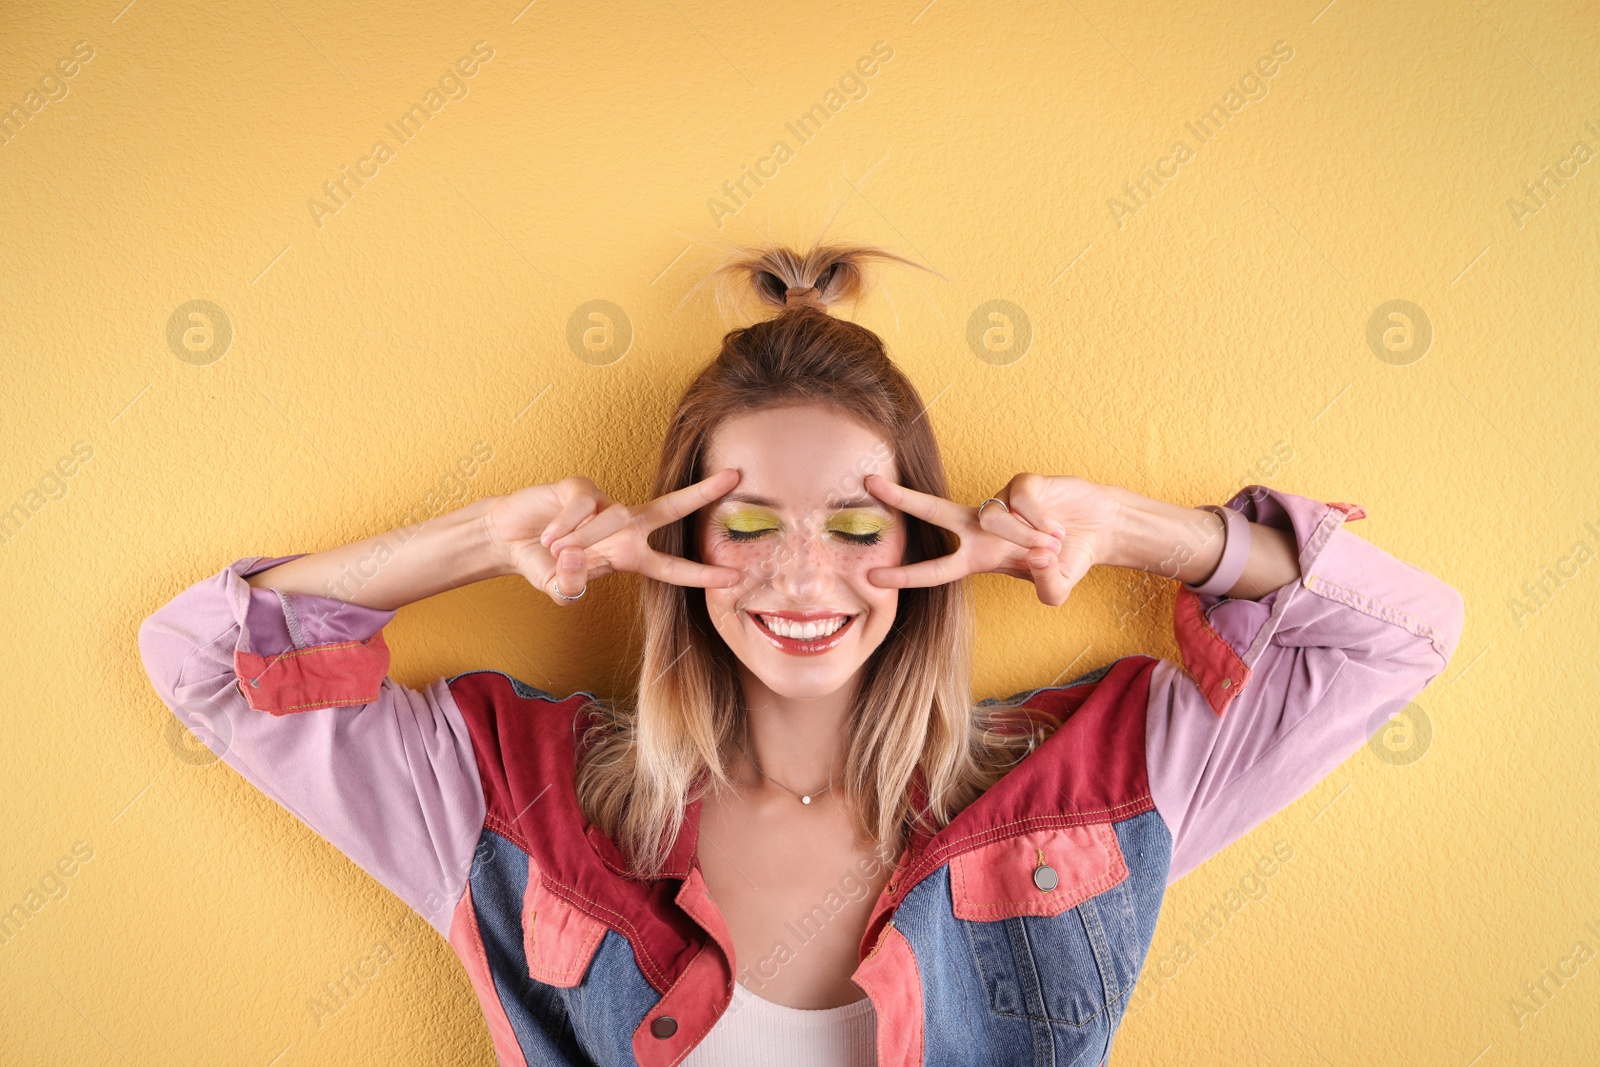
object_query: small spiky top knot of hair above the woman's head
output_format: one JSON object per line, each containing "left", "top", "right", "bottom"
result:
{"left": 696, "top": 245, "right": 936, "bottom": 323}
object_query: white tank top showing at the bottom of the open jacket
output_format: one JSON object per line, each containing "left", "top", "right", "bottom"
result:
{"left": 683, "top": 982, "right": 878, "bottom": 1067}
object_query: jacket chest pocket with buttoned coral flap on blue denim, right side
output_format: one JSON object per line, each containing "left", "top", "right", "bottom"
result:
{"left": 950, "top": 822, "right": 1131, "bottom": 1027}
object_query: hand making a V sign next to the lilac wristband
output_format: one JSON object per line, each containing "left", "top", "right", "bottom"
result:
{"left": 864, "top": 474, "right": 1118, "bottom": 606}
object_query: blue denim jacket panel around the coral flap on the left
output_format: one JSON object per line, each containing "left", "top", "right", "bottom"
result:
{"left": 470, "top": 830, "right": 659, "bottom": 1067}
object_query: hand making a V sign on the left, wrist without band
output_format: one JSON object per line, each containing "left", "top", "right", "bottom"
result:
{"left": 488, "top": 467, "right": 741, "bottom": 606}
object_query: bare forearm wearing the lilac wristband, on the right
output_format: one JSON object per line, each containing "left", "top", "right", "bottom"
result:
{"left": 1099, "top": 485, "right": 1301, "bottom": 600}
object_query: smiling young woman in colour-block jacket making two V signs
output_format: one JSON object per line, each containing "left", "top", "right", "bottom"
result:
{"left": 139, "top": 248, "right": 1462, "bottom": 1067}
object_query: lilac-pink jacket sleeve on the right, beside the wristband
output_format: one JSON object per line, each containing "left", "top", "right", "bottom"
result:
{"left": 1146, "top": 485, "right": 1464, "bottom": 883}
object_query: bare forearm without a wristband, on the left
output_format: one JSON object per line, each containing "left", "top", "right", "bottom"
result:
{"left": 246, "top": 496, "right": 510, "bottom": 611}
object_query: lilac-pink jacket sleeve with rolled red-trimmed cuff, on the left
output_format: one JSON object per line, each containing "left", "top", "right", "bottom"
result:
{"left": 139, "top": 555, "right": 485, "bottom": 937}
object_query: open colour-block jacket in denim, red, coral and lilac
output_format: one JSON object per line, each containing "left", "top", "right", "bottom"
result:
{"left": 139, "top": 485, "right": 1464, "bottom": 1067}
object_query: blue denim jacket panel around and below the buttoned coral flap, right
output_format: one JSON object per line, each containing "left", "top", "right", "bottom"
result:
{"left": 894, "top": 811, "right": 1171, "bottom": 1067}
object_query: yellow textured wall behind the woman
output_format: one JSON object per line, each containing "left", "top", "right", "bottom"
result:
{"left": 0, "top": 0, "right": 1600, "bottom": 1067}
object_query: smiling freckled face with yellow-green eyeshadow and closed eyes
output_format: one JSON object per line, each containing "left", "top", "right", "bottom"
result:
{"left": 696, "top": 403, "right": 906, "bottom": 699}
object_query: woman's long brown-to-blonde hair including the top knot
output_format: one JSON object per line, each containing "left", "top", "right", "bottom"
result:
{"left": 578, "top": 245, "right": 1051, "bottom": 877}
